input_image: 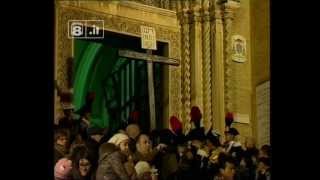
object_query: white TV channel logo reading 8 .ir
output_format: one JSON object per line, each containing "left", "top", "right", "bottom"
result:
{"left": 68, "top": 20, "right": 104, "bottom": 39}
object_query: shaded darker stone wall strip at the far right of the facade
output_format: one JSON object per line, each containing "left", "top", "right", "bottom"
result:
{"left": 250, "top": 0, "right": 270, "bottom": 143}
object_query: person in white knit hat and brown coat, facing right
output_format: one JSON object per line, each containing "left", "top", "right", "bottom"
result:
{"left": 96, "top": 133, "right": 136, "bottom": 180}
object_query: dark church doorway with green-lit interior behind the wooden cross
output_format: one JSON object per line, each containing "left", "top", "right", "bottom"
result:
{"left": 72, "top": 31, "right": 168, "bottom": 133}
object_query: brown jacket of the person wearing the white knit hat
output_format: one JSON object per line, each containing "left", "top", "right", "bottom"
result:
{"left": 96, "top": 143, "right": 131, "bottom": 180}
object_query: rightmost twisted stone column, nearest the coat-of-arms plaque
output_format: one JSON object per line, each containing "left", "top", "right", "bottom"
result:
{"left": 223, "top": 0, "right": 240, "bottom": 112}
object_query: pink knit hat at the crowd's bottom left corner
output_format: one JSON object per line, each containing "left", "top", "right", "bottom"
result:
{"left": 54, "top": 158, "right": 72, "bottom": 180}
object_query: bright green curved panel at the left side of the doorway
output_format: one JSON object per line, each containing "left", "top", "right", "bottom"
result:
{"left": 73, "top": 40, "right": 117, "bottom": 128}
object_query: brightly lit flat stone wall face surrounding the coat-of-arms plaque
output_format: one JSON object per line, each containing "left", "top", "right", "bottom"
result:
{"left": 231, "top": 0, "right": 252, "bottom": 141}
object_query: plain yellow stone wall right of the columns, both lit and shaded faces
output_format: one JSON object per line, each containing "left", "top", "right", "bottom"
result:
{"left": 228, "top": 0, "right": 270, "bottom": 145}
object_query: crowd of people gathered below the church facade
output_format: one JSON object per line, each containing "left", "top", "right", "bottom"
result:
{"left": 54, "top": 100, "right": 271, "bottom": 180}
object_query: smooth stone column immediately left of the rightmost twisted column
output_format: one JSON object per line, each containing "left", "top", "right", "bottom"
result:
{"left": 211, "top": 4, "right": 225, "bottom": 133}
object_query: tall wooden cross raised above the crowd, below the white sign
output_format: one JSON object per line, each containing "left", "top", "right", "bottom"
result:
{"left": 118, "top": 49, "right": 179, "bottom": 130}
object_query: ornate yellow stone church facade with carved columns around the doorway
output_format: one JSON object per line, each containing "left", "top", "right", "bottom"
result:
{"left": 55, "top": 0, "right": 270, "bottom": 146}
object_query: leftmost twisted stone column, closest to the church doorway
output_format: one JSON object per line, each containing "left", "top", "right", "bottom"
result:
{"left": 181, "top": 0, "right": 191, "bottom": 133}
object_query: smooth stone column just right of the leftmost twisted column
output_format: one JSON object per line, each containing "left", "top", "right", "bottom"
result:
{"left": 191, "top": 0, "right": 203, "bottom": 119}
